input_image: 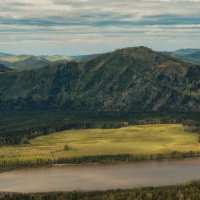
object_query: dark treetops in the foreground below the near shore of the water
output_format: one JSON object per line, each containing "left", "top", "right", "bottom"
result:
{"left": 0, "top": 181, "right": 200, "bottom": 200}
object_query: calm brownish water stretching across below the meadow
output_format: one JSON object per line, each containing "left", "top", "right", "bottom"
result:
{"left": 0, "top": 159, "right": 200, "bottom": 192}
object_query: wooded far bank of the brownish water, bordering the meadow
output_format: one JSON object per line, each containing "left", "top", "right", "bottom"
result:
{"left": 0, "top": 151, "right": 200, "bottom": 173}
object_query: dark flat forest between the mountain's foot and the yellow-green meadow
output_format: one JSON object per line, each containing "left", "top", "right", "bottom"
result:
{"left": 0, "top": 112, "right": 200, "bottom": 145}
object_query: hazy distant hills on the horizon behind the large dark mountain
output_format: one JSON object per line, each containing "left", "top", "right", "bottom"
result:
{"left": 0, "top": 49, "right": 200, "bottom": 70}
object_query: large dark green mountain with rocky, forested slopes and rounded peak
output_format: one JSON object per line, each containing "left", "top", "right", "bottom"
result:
{"left": 0, "top": 47, "right": 200, "bottom": 112}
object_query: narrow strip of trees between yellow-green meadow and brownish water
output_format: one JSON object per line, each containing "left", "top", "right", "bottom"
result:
{"left": 0, "top": 151, "right": 200, "bottom": 172}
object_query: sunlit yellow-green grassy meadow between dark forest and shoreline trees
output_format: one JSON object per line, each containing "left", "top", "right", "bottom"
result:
{"left": 0, "top": 124, "right": 200, "bottom": 166}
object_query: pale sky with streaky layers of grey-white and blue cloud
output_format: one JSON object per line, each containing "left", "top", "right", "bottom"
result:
{"left": 0, "top": 0, "right": 200, "bottom": 55}
